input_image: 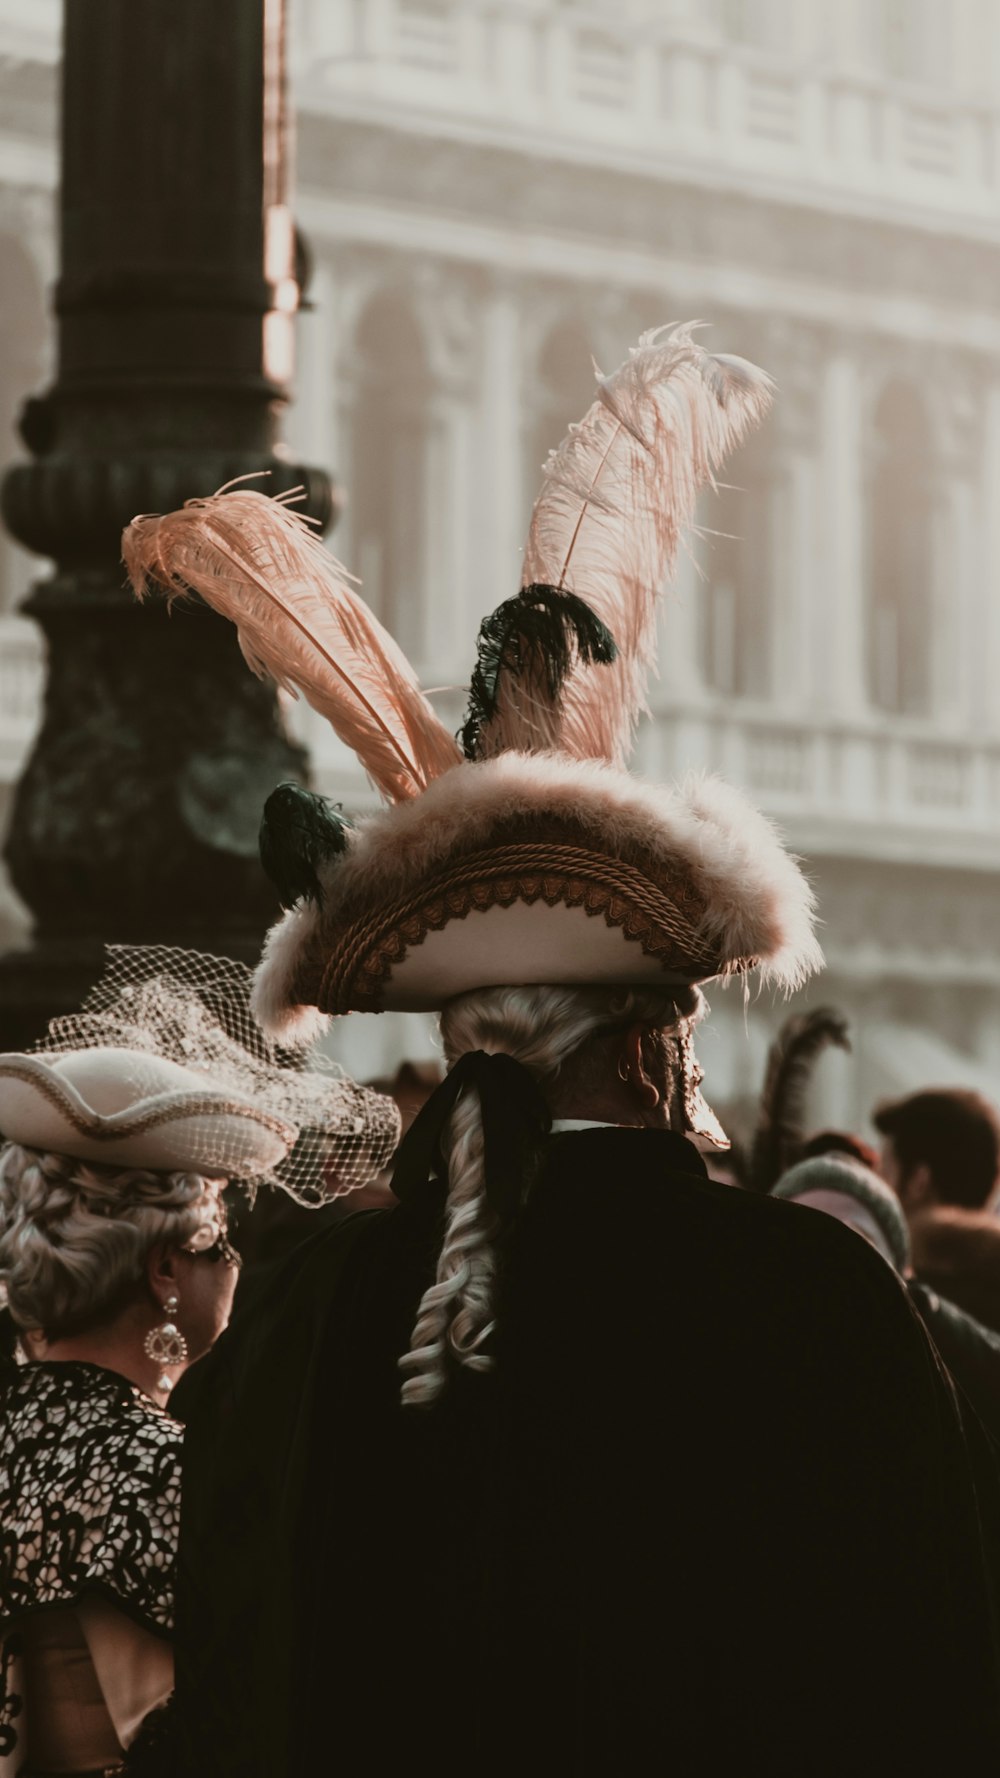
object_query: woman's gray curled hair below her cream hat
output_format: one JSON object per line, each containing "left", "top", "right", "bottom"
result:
{"left": 0, "top": 1141, "right": 215, "bottom": 1339}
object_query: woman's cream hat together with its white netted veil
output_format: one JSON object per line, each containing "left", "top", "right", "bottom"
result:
{"left": 0, "top": 946, "right": 399, "bottom": 1205}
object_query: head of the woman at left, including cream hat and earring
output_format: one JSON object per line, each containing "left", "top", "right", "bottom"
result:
{"left": 0, "top": 946, "right": 297, "bottom": 1405}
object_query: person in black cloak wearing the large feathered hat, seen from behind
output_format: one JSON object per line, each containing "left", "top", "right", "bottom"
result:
{"left": 126, "top": 329, "right": 1000, "bottom": 1778}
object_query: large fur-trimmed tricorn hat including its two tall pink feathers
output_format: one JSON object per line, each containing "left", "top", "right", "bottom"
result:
{"left": 123, "top": 327, "right": 820, "bottom": 1040}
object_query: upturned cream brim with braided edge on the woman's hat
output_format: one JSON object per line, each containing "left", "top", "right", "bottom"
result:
{"left": 0, "top": 1054, "right": 297, "bottom": 1179}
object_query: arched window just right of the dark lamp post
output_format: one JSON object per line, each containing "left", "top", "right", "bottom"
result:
{"left": 349, "top": 292, "right": 431, "bottom": 649}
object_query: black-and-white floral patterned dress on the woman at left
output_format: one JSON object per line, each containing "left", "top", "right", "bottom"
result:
{"left": 0, "top": 1362, "right": 183, "bottom": 1771}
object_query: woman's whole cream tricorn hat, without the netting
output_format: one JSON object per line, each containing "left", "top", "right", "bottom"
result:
{"left": 0, "top": 1049, "right": 299, "bottom": 1179}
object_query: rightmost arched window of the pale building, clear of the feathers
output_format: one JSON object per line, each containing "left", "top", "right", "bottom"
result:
{"left": 868, "top": 382, "right": 932, "bottom": 717}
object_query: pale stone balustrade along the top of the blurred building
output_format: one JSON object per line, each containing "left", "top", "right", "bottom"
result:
{"left": 295, "top": 0, "right": 1000, "bottom": 226}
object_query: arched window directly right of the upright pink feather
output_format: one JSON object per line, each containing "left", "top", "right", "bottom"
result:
{"left": 696, "top": 428, "right": 774, "bottom": 697}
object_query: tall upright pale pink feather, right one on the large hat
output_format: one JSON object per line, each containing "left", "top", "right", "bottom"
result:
{"left": 505, "top": 322, "right": 774, "bottom": 765}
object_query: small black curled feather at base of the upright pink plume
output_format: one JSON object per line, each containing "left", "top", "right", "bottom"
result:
{"left": 459, "top": 587, "right": 617, "bottom": 759}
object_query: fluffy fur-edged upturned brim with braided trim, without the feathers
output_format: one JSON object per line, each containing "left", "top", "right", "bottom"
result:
{"left": 253, "top": 754, "right": 822, "bottom": 1037}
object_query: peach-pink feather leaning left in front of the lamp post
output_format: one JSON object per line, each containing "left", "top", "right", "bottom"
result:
{"left": 121, "top": 489, "right": 461, "bottom": 802}
